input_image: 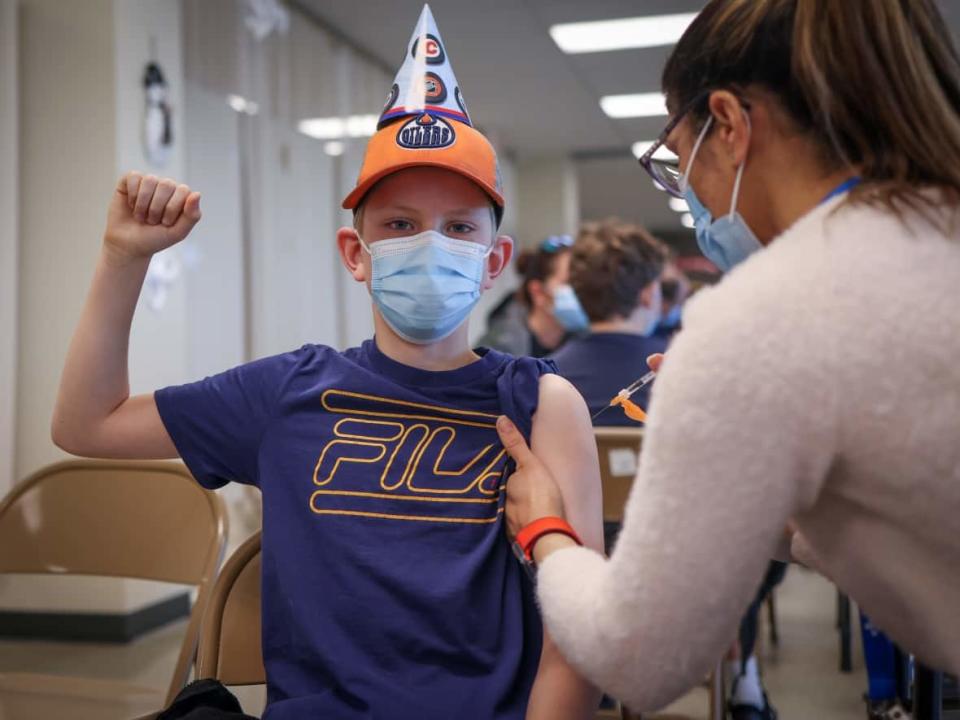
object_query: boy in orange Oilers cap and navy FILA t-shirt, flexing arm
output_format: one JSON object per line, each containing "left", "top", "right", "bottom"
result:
{"left": 52, "top": 8, "right": 602, "bottom": 720}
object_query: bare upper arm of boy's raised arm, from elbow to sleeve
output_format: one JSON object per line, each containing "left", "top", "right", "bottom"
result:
{"left": 54, "top": 393, "right": 179, "bottom": 460}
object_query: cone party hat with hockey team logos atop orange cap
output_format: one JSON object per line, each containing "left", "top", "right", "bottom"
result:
{"left": 377, "top": 5, "right": 472, "bottom": 129}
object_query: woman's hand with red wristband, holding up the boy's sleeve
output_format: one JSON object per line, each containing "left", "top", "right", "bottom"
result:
{"left": 497, "top": 415, "right": 564, "bottom": 538}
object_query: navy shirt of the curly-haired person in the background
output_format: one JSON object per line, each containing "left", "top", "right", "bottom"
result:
{"left": 550, "top": 333, "right": 667, "bottom": 427}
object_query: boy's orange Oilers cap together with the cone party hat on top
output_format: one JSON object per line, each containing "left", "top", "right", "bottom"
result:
{"left": 343, "top": 5, "right": 504, "bottom": 222}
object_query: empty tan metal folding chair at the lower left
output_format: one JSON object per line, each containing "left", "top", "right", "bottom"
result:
{"left": 0, "top": 460, "right": 227, "bottom": 720}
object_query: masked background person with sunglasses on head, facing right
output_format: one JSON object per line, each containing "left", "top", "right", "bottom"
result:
{"left": 478, "top": 235, "right": 589, "bottom": 358}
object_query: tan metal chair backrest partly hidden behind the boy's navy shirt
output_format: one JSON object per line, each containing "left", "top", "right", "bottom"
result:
{"left": 197, "top": 532, "right": 267, "bottom": 685}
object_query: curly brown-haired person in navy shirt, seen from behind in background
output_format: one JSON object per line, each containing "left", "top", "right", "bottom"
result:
{"left": 550, "top": 221, "right": 667, "bottom": 427}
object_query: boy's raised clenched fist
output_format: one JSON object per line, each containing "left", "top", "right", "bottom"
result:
{"left": 104, "top": 172, "right": 200, "bottom": 259}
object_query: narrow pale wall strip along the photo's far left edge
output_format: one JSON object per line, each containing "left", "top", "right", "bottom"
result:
{"left": 0, "top": 0, "right": 19, "bottom": 496}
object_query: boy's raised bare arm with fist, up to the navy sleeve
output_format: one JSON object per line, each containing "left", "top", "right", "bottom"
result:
{"left": 51, "top": 173, "right": 200, "bottom": 458}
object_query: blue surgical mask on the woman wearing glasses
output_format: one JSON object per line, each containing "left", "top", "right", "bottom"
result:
{"left": 682, "top": 115, "right": 763, "bottom": 272}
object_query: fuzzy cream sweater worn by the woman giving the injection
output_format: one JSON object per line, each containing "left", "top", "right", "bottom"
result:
{"left": 539, "top": 198, "right": 960, "bottom": 711}
